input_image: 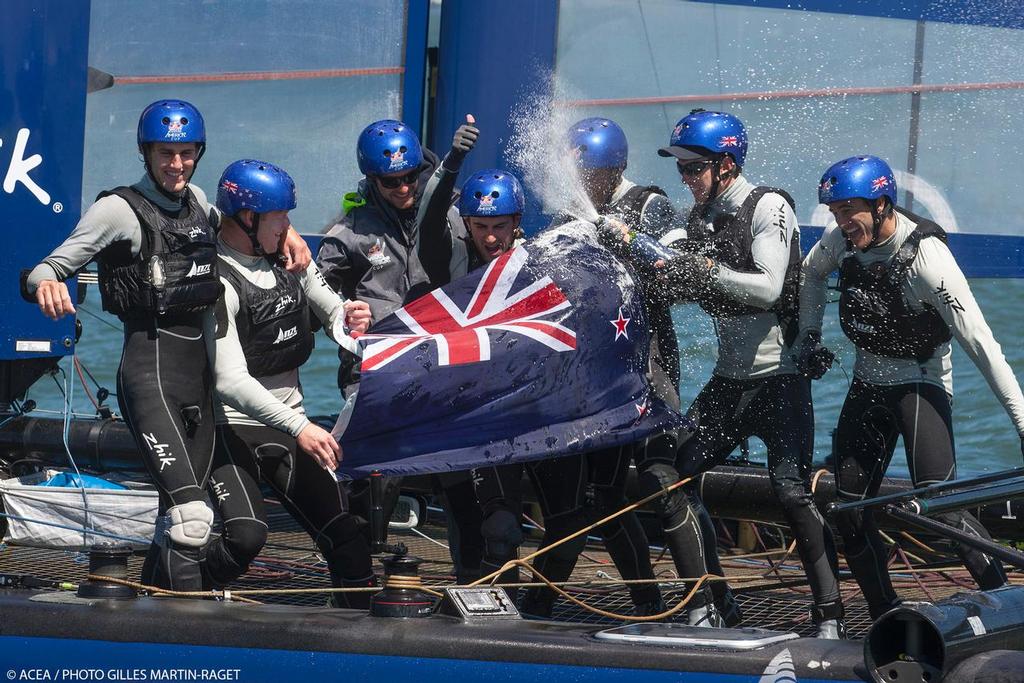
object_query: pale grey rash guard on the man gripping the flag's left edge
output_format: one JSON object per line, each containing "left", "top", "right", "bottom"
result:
{"left": 204, "top": 240, "right": 356, "bottom": 436}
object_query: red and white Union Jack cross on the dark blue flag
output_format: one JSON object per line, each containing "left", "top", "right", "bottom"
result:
{"left": 361, "top": 247, "right": 577, "bottom": 372}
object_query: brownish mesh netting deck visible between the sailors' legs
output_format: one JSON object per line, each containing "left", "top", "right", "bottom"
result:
{"left": 0, "top": 493, "right": 1007, "bottom": 638}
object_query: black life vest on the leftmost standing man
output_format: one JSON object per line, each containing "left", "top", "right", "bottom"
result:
{"left": 96, "top": 186, "right": 223, "bottom": 319}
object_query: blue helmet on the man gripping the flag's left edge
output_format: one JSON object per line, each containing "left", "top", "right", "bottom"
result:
{"left": 217, "top": 159, "right": 296, "bottom": 216}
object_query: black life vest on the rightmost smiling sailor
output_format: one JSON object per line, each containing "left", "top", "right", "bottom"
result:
{"left": 839, "top": 208, "right": 952, "bottom": 362}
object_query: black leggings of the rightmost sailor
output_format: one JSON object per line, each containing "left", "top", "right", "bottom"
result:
{"left": 836, "top": 380, "right": 1007, "bottom": 617}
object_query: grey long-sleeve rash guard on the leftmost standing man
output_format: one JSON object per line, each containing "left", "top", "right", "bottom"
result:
{"left": 28, "top": 175, "right": 220, "bottom": 293}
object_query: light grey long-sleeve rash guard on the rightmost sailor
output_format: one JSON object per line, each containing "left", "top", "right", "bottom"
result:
{"left": 800, "top": 214, "right": 1024, "bottom": 435}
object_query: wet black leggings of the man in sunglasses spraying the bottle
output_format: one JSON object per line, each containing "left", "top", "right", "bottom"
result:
{"left": 638, "top": 375, "right": 840, "bottom": 617}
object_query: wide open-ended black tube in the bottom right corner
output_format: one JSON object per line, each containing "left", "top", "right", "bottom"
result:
{"left": 864, "top": 586, "right": 1024, "bottom": 683}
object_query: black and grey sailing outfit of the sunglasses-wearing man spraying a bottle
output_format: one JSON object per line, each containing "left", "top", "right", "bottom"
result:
{"left": 638, "top": 176, "right": 842, "bottom": 623}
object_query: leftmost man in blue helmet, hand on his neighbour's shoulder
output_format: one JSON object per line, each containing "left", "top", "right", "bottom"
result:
{"left": 27, "top": 99, "right": 309, "bottom": 591}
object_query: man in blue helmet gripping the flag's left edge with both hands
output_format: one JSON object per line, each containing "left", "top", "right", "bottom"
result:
{"left": 205, "top": 159, "right": 374, "bottom": 607}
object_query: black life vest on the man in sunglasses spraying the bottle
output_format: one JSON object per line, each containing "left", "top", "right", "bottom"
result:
{"left": 686, "top": 186, "right": 803, "bottom": 345}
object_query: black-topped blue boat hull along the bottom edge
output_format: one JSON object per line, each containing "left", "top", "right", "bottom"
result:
{"left": 0, "top": 590, "right": 864, "bottom": 683}
